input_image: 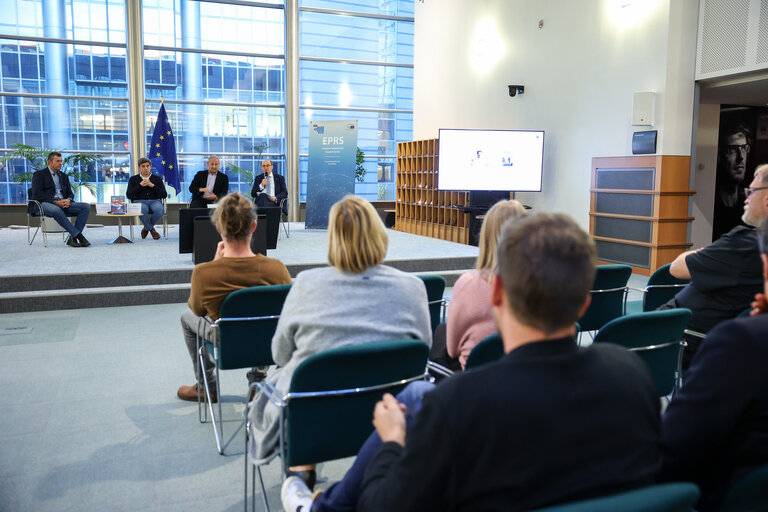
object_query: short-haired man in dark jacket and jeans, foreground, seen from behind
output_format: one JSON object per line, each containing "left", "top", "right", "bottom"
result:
{"left": 282, "top": 214, "right": 661, "bottom": 512}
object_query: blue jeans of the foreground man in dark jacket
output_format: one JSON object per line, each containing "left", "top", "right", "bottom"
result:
{"left": 312, "top": 380, "right": 435, "bottom": 512}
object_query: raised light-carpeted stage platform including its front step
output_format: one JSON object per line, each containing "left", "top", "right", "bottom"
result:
{"left": 0, "top": 223, "right": 478, "bottom": 313}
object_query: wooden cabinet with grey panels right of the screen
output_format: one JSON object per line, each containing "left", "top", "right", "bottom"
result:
{"left": 589, "top": 156, "right": 695, "bottom": 275}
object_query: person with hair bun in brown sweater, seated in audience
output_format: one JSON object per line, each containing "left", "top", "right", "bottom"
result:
{"left": 177, "top": 192, "right": 291, "bottom": 403}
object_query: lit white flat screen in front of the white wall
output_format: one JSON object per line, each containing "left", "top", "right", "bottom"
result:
{"left": 437, "top": 128, "right": 544, "bottom": 192}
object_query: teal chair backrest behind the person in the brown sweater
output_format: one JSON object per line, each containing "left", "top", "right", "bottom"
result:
{"left": 216, "top": 284, "right": 291, "bottom": 370}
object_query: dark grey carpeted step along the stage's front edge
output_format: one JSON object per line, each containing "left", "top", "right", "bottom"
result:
{"left": 0, "top": 257, "right": 475, "bottom": 313}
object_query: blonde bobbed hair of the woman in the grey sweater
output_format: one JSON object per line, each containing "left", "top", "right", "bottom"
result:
{"left": 328, "top": 195, "right": 389, "bottom": 274}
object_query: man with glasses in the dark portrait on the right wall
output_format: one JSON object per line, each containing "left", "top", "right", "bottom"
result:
{"left": 712, "top": 124, "right": 751, "bottom": 240}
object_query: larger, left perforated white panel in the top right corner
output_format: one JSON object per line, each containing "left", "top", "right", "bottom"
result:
{"left": 699, "top": 0, "right": 749, "bottom": 73}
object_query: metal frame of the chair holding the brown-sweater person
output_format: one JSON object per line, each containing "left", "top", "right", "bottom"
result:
{"left": 196, "top": 315, "right": 280, "bottom": 455}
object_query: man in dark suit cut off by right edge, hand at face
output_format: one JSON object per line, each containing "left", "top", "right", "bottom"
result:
{"left": 662, "top": 216, "right": 768, "bottom": 512}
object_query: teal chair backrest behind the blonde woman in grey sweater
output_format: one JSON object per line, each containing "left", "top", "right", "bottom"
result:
{"left": 284, "top": 339, "right": 429, "bottom": 466}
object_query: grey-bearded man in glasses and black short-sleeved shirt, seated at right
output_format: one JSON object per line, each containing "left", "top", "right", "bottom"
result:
{"left": 661, "top": 164, "right": 768, "bottom": 367}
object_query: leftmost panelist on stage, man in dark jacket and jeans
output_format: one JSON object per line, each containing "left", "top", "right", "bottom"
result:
{"left": 28, "top": 151, "right": 91, "bottom": 247}
